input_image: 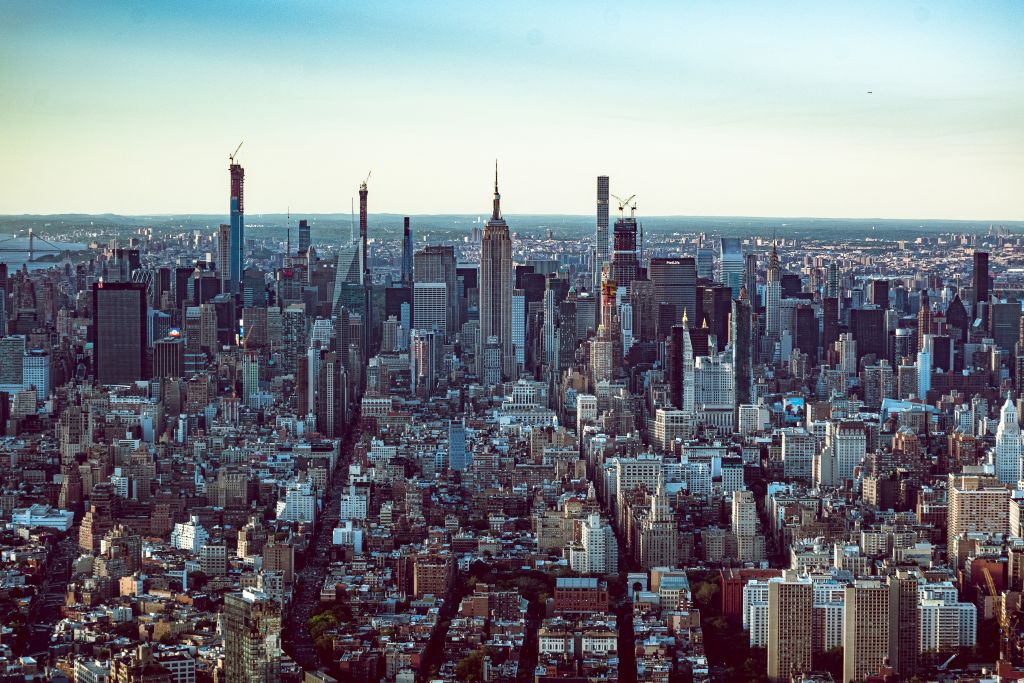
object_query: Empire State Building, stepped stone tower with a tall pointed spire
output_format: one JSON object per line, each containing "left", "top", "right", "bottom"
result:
{"left": 480, "top": 162, "right": 515, "bottom": 379}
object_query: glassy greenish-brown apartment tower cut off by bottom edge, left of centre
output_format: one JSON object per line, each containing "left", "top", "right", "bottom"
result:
{"left": 222, "top": 588, "right": 281, "bottom": 683}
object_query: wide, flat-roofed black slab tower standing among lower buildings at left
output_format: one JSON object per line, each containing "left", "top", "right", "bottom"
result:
{"left": 91, "top": 282, "right": 150, "bottom": 384}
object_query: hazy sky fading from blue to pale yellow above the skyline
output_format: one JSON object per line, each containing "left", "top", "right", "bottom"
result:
{"left": 0, "top": 0, "right": 1024, "bottom": 220}
